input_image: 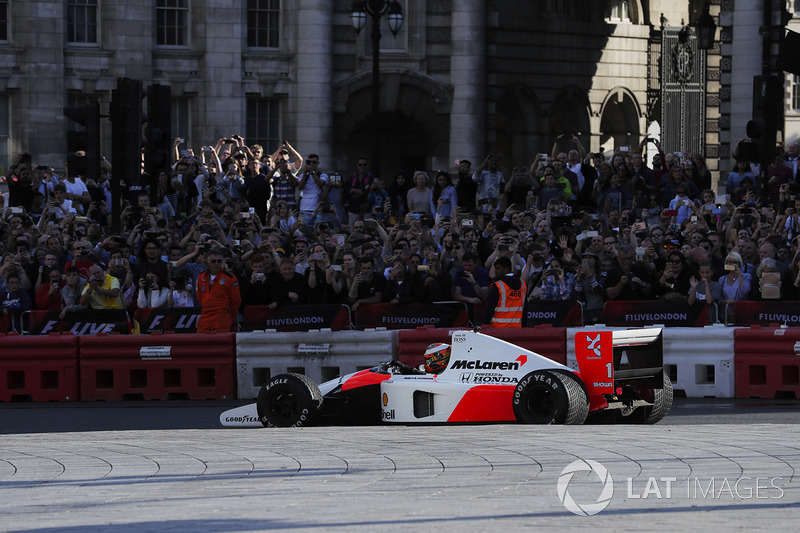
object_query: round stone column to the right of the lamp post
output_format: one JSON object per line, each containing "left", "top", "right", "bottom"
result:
{"left": 449, "top": 0, "right": 487, "bottom": 164}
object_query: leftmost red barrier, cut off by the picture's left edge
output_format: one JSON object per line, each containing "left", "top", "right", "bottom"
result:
{"left": 0, "top": 333, "right": 79, "bottom": 402}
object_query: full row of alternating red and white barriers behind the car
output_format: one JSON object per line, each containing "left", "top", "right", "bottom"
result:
{"left": 0, "top": 325, "right": 800, "bottom": 402}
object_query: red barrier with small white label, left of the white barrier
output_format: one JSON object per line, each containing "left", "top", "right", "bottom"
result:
{"left": 79, "top": 333, "right": 236, "bottom": 401}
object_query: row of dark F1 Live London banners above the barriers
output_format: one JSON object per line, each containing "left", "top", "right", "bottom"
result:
{"left": 15, "top": 300, "right": 800, "bottom": 335}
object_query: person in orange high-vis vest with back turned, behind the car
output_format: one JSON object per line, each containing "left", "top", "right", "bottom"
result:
{"left": 483, "top": 257, "right": 528, "bottom": 328}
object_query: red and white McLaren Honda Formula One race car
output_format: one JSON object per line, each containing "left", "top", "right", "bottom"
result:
{"left": 220, "top": 328, "right": 672, "bottom": 427}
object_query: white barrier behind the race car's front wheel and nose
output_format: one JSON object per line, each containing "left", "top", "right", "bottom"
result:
{"left": 236, "top": 329, "right": 397, "bottom": 400}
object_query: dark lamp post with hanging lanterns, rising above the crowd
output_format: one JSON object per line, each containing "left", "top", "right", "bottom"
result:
{"left": 350, "top": 0, "right": 403, "bottom": 177}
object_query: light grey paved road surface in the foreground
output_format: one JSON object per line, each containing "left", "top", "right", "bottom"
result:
{"left": 0, "top": 422, "right": 800, "bottom": 533}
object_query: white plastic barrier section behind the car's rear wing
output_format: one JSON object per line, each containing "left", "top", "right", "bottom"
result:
{"left": 567, "top": 324, "right": 736, "bottom": 398}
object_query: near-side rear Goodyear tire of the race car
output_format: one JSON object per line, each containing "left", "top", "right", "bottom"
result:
{"left": 513, "top": 370, "right": 589, "bottom": 424}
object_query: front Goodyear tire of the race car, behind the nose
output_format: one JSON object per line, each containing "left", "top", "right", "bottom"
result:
{"left": 256, "top": 374, "right": 322, "bottom": 427}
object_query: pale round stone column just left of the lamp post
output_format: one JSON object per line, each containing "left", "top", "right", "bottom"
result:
{"left": 294, "top": 0, "right": 334, "bottom": 164}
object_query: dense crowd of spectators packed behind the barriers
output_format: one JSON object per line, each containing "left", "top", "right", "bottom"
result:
{"left": 0, "top": 135, "right": 800, "bottom": 331}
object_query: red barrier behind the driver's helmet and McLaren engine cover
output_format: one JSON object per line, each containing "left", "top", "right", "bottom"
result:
{"left": 397, "top": 326, "right": 567, "bottom": 366}
